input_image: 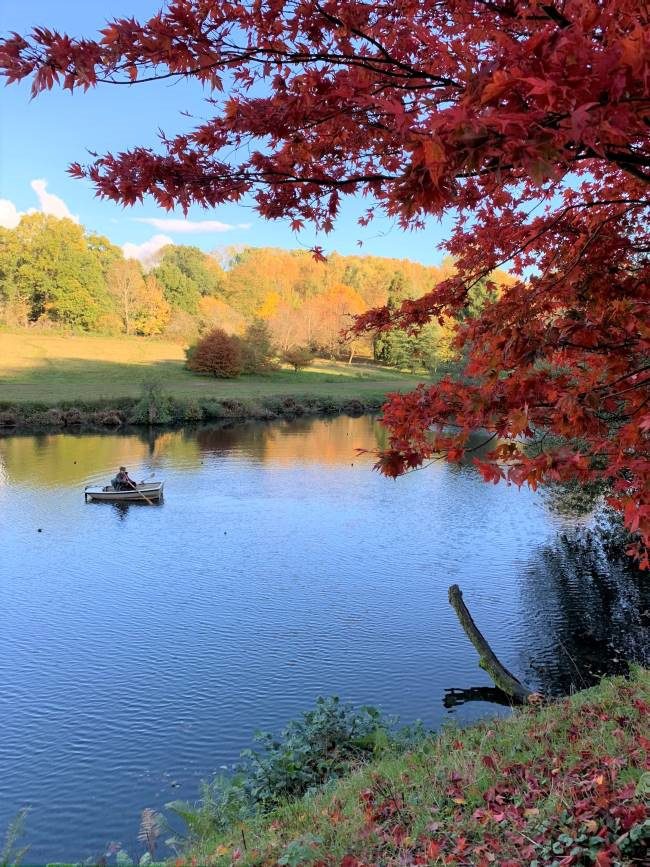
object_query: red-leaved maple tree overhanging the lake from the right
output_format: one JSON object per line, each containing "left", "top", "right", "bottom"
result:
{"left": 0, "top": 0, "right": 650, "bottom": 567}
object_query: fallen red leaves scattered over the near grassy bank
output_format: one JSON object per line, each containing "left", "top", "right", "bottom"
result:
{"left": 322, "top": 699, "right": 650, "bottom": 867}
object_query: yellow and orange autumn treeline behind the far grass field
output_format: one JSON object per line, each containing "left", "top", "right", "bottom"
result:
{"left": 0, "top": 213, "right": 507, "bottom": 369}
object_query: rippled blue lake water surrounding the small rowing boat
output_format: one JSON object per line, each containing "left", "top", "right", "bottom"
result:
{"left": 0, "top": 418, "right": 645, "bottom": 863}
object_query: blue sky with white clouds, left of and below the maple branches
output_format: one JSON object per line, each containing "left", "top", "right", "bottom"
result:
{"left": 0, "top": 0, "right": 448, "bottom": 264}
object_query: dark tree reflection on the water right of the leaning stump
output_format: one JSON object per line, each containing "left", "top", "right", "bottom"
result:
{"left": 521, "top": 518, "right": 650, "bottom": 695}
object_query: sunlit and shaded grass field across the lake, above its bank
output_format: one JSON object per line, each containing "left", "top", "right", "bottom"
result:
{"left": 0, "top": 331, "right": 421, "bottom": 406}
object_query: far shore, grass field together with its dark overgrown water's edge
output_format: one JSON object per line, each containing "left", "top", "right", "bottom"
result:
{"left": 0, "top": 332, "right": 422, "bottom": 432}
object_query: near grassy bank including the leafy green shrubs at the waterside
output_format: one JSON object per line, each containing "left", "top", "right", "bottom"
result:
{"left": 0, "top": 668, "right": 650, "bottom": 867}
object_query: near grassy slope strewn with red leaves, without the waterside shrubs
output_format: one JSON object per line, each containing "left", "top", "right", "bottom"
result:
{"left": 175, "top": 670, "right": 650, "bottom": 867}
